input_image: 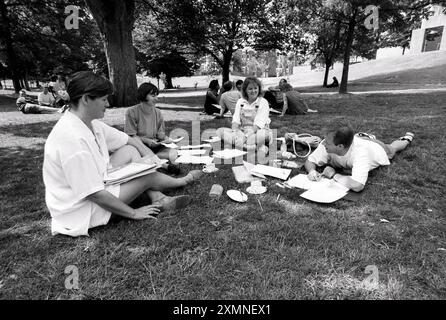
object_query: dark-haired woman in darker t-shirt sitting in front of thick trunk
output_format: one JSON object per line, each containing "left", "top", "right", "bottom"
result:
{"left": 124, "top": 82, "right": 178, "bottom": 162}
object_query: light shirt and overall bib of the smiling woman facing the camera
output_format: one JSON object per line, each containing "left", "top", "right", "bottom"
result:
{"left": 232, "top": 97, "right": 271, "bottom": 129}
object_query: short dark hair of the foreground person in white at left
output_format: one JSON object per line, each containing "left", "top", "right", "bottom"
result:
{"left": 67, "top": 71, "right": 113, "bottom": 106}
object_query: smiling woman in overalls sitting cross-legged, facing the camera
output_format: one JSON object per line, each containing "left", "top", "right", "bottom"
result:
{"left": 217, "top": 77, "right": 272, "bottom": 154}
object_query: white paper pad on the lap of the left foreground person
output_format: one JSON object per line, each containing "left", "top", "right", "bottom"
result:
{"left": 104, "top": 162, "right": 159, "bottom": 185}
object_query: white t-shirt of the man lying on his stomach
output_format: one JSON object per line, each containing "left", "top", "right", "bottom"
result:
{"left": 308, "top": 137, "right": 390, "bottom": 185}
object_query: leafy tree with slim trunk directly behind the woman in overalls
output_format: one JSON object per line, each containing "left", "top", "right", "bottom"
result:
{"left": 155, "top": 0, "right": 269, "bottom": 82}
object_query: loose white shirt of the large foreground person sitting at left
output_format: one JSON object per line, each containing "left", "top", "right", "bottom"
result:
{"left": 43, "top": 112, "right": 128, "bottom": 237}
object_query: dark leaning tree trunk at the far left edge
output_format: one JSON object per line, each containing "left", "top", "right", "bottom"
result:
{"left": 0, "top": 0, "right": 22, "bottom": 93}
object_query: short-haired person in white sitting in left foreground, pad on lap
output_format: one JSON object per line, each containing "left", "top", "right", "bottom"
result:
{"left": 43, "top": 71, "right": 201, "bottom": 237}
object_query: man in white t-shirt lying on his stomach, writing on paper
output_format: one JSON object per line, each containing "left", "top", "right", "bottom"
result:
{"left": 305, "top": 126, "right": 414, "bottom": 192}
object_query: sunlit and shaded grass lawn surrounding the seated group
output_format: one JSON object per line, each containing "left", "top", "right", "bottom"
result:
{"left": 0, "top": 93, "right": 446, "bottom": 299}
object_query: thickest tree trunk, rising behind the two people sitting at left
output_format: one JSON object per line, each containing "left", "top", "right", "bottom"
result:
{"left": 85, "top": 0, "right": 137, "bottom": 107}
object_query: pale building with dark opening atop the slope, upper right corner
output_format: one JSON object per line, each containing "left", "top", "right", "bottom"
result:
{"left": 410, "top": 6, "right": 446, "bottom": 54}
